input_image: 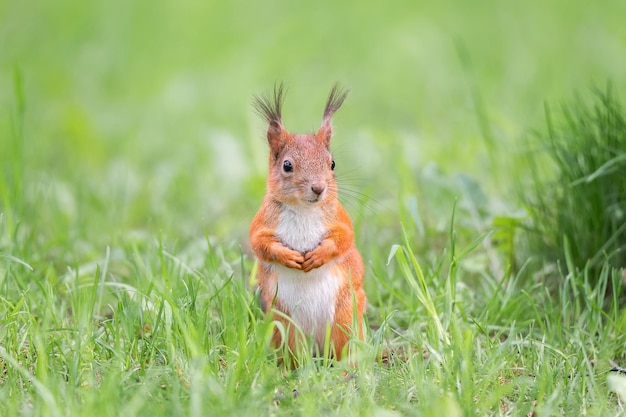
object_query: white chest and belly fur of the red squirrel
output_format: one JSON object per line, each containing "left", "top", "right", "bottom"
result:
{"left": 274, "top": 208, "right": 341, "bottom": 348}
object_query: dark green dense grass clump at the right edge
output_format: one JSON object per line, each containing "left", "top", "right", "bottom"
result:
{"left": 522, "top": 87, "right": 626, "bottom": 283}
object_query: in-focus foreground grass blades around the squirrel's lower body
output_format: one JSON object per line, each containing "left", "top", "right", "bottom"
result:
{"left": 0, "top": 213, "right": 626, "bottom": 416}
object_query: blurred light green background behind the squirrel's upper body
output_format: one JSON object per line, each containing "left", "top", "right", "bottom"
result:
{"left": 0, "top": 0, "right": 626, "bottom": 262}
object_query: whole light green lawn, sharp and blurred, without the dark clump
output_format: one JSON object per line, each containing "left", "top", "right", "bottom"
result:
{"left": 0, "top": 0, "right": 626, "bottom": 416}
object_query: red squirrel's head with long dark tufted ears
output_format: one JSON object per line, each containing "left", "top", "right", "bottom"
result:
{"left": 253, "top": 83, "right": 348, "bottom": 206}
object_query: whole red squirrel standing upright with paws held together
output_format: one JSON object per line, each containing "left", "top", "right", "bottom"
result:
{"left": 250, "top": 84, "right": 366, "bottom": 360}
